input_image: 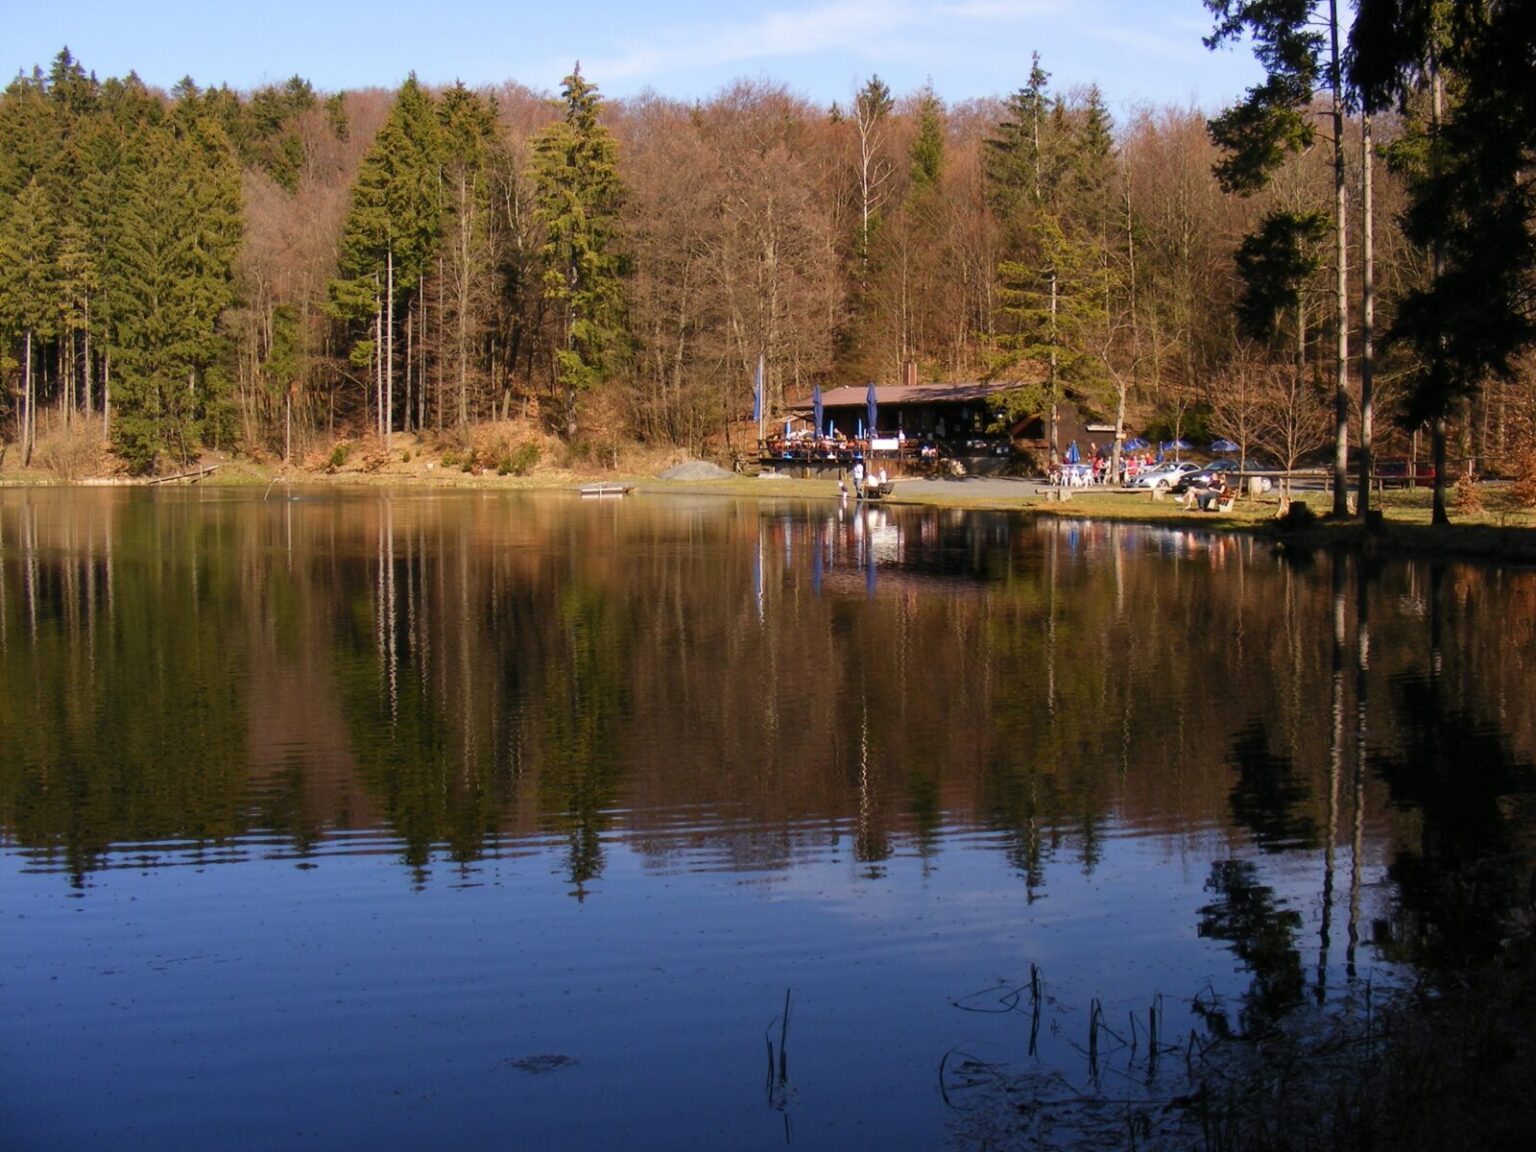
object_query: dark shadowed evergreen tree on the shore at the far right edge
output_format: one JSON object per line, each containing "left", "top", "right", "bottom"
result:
{"left": 1352, "top": 0, "right": 1536, "bottom": 524}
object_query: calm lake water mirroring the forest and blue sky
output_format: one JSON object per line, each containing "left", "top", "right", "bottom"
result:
{"left": 0, "top": 488, "right": 1536, "bottom": 1150}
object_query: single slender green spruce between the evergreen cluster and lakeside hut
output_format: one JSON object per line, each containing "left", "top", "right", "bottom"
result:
{"left": 533, "top": 65, "right": 628, "bottom": 436}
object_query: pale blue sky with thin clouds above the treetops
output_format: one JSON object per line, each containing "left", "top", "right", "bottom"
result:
{"left": 0, "top": 0, "right": 1258, "bottom": 109}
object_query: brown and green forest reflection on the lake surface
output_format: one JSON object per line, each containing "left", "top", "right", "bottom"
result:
{"left": 0, "top": 493, "right": 1530, "bottom": 903}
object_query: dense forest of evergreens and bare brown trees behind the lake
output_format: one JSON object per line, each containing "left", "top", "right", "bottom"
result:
{"left": 0, "top": 0, "right": 1536, "bottom": 513}
